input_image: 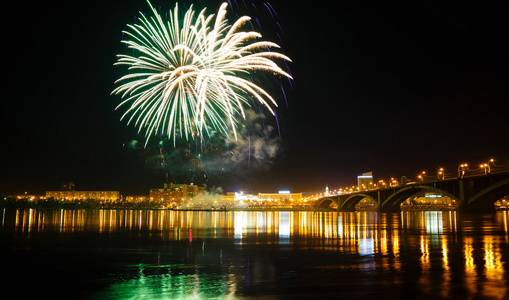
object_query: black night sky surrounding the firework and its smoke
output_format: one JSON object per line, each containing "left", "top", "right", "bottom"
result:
{"left": 0, "top": 0, "right": 509, "bottom": 195}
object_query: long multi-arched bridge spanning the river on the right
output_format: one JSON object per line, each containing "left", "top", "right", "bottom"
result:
{"left": 315, "top": 172, "right": 509, "bottom": 211}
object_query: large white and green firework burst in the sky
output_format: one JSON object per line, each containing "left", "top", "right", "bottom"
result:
{"left": 112, "top": 2, "right": 291, "bottom": 143}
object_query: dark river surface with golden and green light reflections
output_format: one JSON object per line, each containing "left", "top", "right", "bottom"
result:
{"left": 0, "top": 209, "right": 509, "bottom": 299}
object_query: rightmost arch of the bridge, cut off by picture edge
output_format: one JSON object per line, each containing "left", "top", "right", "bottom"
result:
{"left": 463, "top": 178, "right": 509, "bottom": 211}
